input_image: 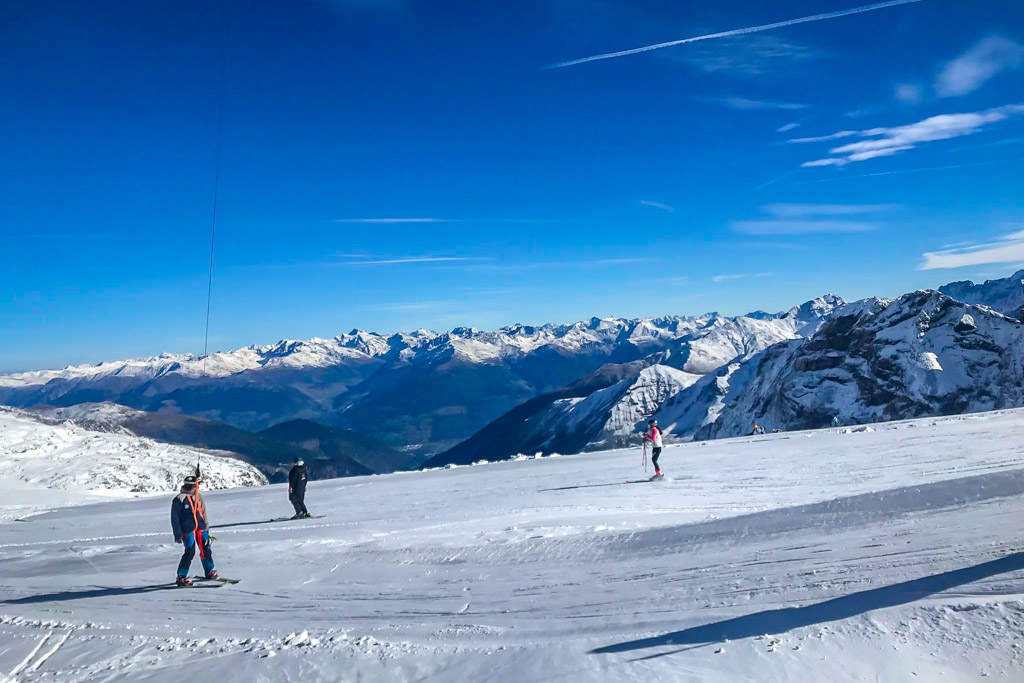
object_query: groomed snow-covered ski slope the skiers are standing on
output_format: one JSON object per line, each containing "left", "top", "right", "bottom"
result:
{"left": 0, "top": 411, "right": 1024, "bottom": 683}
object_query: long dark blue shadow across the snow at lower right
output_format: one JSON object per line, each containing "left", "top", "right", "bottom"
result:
{"left": 590, "top": 552, "right": 1024, "bottom": 654}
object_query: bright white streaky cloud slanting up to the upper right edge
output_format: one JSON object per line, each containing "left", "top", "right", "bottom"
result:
{"left": 803, "top": 104, "right": 1024, "bottom": 167}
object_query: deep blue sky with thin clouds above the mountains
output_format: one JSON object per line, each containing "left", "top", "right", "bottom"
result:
{"left": 0, "top": 0, "right": 1024, "bottom": 371}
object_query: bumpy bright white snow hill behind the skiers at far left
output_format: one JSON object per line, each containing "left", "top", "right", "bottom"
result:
{"left": 0, "top": 407, "right": 266, "bottom": 520}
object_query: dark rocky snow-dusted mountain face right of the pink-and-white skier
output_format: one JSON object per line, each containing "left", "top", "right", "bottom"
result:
{"left": 696, "top": 291, "right": 1024, "bottom": 438}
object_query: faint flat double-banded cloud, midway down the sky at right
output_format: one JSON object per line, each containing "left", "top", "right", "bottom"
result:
{"left": 732, "top": 204, "right": 898, "bottom": 234}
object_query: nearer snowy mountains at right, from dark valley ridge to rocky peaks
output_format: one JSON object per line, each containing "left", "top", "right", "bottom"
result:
{"left": 427, "top": 271, "right": 1024, "bottom": 466}
